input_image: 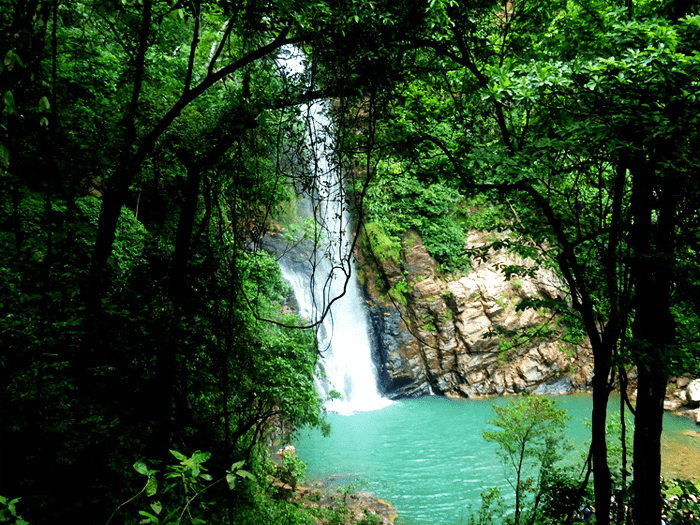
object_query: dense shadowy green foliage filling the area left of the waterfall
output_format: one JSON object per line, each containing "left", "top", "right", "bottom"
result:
{"left": 0, "top": 0, "right": 342, "bottom": 523}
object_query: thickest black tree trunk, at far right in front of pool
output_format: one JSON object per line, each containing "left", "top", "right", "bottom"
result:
{"left": 630, "top": 147, "right": 675, "bottom": 525}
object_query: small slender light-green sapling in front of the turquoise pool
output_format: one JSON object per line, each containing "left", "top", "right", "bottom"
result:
{"left": 482, "top": 395, "right": 569, "bottom": 525}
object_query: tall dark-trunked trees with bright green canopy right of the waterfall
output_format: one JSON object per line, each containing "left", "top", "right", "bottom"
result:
{"left": 348, "top": 1, "right": 699, "bottom": 523}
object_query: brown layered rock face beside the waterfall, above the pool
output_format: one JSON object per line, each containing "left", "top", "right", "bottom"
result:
{"left": 360, "top": 232, "right": 593, "bottom": 398}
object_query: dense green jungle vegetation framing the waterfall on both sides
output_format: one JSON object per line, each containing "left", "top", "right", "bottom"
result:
{"left": 0, "top": 0, "right": 700, "bottom": 525}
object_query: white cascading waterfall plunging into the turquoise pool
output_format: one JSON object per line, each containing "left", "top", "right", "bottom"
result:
{"left": 279, "top": 50, "right": 391, "bottom": 414}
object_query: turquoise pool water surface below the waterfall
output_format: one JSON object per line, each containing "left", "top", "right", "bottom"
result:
{"left": 297, "top": 395, "right": 700, "bottom": 525}
